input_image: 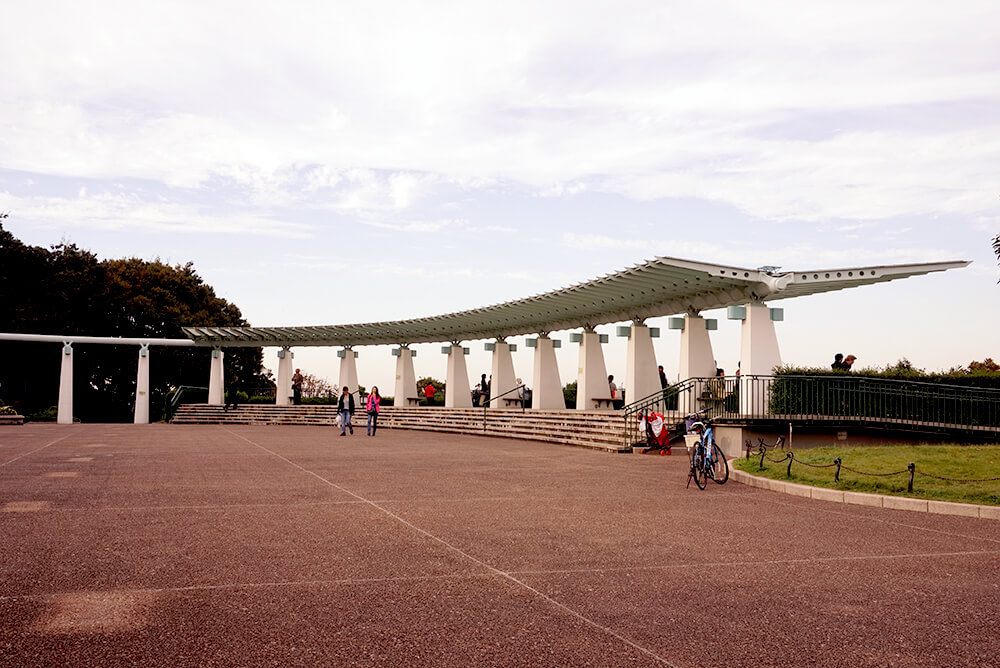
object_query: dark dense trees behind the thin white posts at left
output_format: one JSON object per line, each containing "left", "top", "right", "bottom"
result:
{"left": 0, "top": 214, "right": 273, "bottom": 422}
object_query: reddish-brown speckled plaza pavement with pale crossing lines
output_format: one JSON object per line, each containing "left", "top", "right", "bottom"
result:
{"left": 0, "top": 424, "right": 1000, "bottom": 667}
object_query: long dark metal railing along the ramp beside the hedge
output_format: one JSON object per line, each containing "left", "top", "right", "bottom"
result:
{"left": 625, "top": 375, "right": 1000, "bottom": 446}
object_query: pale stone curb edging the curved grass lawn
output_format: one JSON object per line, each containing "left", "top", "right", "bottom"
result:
{"left": 729, "top": 460, "right": 1000, "bottom": 520}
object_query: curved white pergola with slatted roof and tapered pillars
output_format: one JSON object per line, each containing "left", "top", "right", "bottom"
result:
{"left": 0, "top": 257, "right": 969, "bottom": 422}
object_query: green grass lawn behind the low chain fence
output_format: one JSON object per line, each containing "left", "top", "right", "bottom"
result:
{"left": 733, "top": 445, "right": 1000, "bottom": 506}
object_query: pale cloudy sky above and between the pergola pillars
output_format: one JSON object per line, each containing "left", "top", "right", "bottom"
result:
{"left": 0, "top": 0, "right": 1000, "bottom": 394}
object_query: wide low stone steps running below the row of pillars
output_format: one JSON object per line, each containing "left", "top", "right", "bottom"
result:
{"left": 171, "top": 404, "right": 631, "bottom": 452}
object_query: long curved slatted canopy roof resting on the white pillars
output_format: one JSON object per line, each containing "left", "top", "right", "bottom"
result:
{"left": 183, "top": 257, "right": 969, "bottom": 346}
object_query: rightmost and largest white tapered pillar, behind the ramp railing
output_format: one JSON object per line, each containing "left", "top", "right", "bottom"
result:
{"left": 728, "top": 304, "right": 785, "bottom": 414}
